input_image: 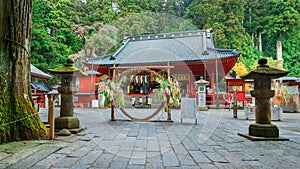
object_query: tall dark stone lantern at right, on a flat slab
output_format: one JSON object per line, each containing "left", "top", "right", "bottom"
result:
{"left": 240, "top": 59, "right": 289, "bottom": 139}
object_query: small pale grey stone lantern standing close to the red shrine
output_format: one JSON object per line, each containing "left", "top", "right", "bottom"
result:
{"left": 195, "top": 76, "right": 209, "bottom": 111}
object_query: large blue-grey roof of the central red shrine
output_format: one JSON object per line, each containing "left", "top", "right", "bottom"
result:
{"left": 86, "top": 30, "right": 239, "bottom": 65}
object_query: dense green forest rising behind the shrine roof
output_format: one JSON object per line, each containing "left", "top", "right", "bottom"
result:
{"left": 31, "top": 0, "right": 300, "bottom": 83}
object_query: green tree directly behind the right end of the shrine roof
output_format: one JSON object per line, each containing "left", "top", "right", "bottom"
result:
{"left": 186, "top": 0, "right": 259, "bottom": 68}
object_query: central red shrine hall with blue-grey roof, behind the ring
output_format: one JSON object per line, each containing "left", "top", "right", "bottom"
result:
{"left": 79, "top": 30, "right": 240, "bottom": 107}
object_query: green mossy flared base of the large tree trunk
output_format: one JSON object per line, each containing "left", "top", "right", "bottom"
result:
{"left": 0, "top": 95, "right": 47, "bottom": 143}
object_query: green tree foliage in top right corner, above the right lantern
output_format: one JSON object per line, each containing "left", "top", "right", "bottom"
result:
{"left": 244, "top": 0, "right": 300, "bottom": 77}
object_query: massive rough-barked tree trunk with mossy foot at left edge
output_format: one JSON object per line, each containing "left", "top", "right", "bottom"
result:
{"left": 0, "top": 0, "right": 46, "bottom": 143}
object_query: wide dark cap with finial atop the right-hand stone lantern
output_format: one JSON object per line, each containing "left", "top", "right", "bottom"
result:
{"left": 241, "top": 58, "right": 289, "bottom": 79}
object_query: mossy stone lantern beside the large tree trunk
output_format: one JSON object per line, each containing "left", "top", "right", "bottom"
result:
{"left": 49, "top": 59, "right": 87, "bottom": 129}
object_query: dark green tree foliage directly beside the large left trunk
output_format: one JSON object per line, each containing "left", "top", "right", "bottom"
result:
{"left": 31, "top": 0, "right": 83, "bottom": 72}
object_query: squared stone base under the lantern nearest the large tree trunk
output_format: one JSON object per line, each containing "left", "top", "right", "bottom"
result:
{"left": 55, "top": 117, "right": 79, "bottom": 130}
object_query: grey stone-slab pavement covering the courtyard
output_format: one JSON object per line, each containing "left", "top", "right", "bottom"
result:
{"left": 0, "top": 109, "right": 300, "bottom": 169}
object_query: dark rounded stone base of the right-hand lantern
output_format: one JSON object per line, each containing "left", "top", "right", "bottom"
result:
{"left": 249, "top": 123, "right": 279, "bottom": 138}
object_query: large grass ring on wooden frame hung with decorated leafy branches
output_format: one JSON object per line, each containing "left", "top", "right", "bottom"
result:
{"left": 111, "top": 66, "right": 180, "bottom": 122}
